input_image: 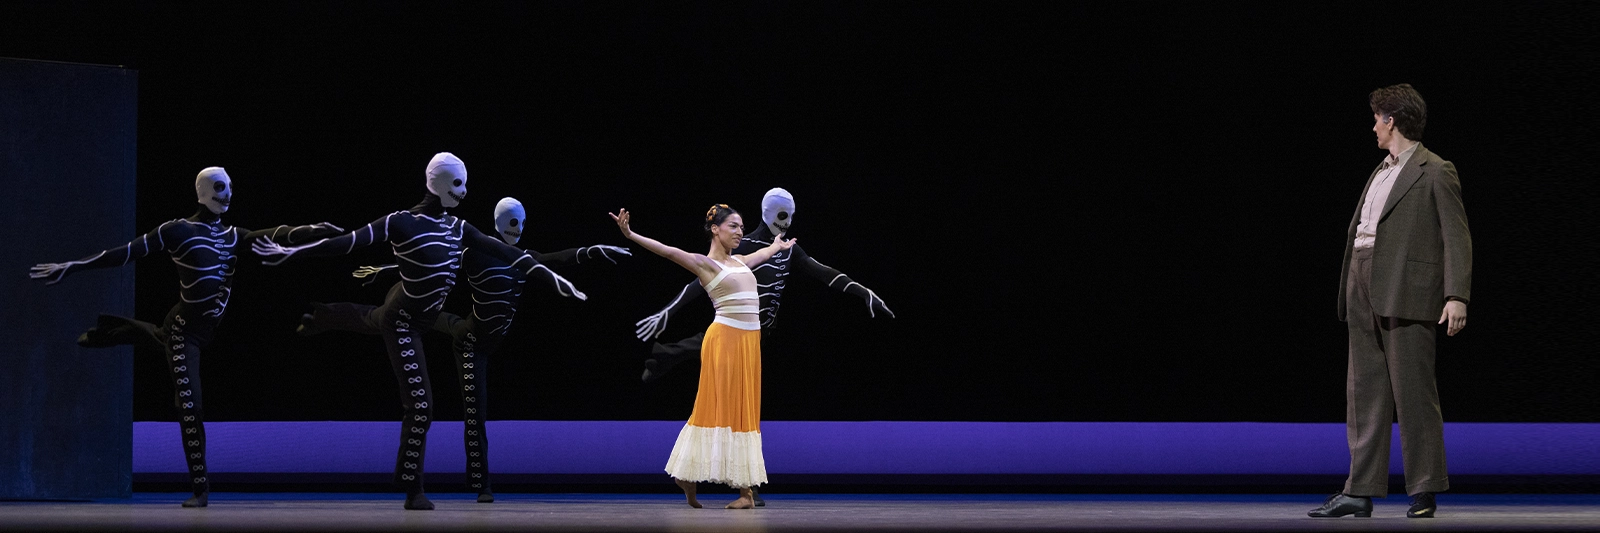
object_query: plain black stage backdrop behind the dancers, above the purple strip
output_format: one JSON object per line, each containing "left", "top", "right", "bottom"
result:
{"left": 0, "top": 2, "right": 1600, "bottom": 423}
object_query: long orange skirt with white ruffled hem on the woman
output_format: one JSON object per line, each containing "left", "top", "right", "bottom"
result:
{"left": 667, "top": 323, "right": 766, "bottom": 487}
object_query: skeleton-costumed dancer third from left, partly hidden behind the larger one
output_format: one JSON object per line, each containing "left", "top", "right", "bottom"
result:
{"left": 296, "top": 198, "right": 632, "bottom": 503}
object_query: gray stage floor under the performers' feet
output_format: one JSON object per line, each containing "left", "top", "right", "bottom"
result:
{"left": 0, "top": 493, "right": 1600, "bottom": 531}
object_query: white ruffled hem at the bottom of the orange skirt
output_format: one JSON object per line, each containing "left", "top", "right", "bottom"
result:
{"left": 667, "top": 424, "right": 766, "bottom": 488}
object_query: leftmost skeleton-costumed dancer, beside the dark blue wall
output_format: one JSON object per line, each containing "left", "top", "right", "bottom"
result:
{"left": 29, "top": 166, "right": 344, "bottom": 507}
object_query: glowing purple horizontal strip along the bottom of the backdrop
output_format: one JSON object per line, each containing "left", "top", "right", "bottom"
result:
{"left": 133, "top": 421, "right": 1600, "bottom": 475}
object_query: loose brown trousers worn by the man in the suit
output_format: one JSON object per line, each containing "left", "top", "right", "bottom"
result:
{"left": 1344, "top": 248, "right": 1450, "bottom": 498}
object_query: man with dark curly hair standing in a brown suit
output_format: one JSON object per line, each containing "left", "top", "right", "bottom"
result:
{"left": 1310, "top": 83, "right": 1472, "bottom": 519}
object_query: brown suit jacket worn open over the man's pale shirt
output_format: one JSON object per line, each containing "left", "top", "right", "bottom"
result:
{"left": 1339, "top": 144, "right": 1472, "bottom": 322}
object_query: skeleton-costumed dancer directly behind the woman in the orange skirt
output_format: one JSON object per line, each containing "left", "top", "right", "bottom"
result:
{"left": 635, "top": 189, "right": 894, "bottom": 381}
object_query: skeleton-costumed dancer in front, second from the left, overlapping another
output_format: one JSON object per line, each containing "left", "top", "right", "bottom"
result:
{"left": 251, "top": 152, "right": 586, "bottom": 511}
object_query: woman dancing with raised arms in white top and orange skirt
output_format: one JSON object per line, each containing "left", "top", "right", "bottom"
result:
{"left": 611, "top": 203, "right": 795, "bottom": 509}
